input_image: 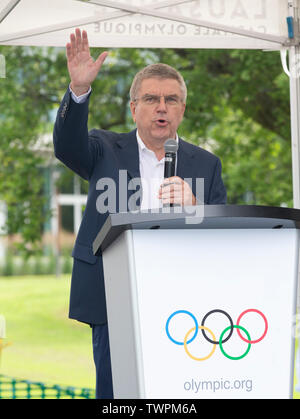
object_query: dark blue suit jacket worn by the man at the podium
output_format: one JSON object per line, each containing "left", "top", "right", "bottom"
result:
{"left": 53, "top": 91, "right": 226, "bottom": 324}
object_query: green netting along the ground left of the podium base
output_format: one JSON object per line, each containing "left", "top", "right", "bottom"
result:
{"left": 0, "top": 374, "right": 95, "bottom": 399}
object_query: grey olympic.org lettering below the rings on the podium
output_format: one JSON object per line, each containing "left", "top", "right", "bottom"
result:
{"left": 183, "top": 378, "right": 253, "bottom": 394}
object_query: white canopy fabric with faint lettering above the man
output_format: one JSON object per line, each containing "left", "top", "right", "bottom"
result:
{"left": 0, "top": 0, "right": 288, "bottom": 49}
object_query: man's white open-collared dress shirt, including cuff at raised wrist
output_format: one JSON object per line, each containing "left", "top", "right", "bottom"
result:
{"left": 70, "top": 87, "right": 178, "bottom": 210}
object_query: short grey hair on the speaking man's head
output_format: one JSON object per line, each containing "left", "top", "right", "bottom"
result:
{"left": 129, "top": 63, "right": 187, "bottom": 102}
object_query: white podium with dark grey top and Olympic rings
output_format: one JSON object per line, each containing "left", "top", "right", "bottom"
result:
{"left": 93, "top": 206, "right": 300, "bottom": 399}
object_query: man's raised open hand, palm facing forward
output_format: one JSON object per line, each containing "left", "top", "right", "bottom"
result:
{"left": 66, "top": 28, "right": 108, "bottom": 96}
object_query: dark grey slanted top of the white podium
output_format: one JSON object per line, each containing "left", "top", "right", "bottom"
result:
{"left": 93, "top": 205, "right": 300, "bottom": 255}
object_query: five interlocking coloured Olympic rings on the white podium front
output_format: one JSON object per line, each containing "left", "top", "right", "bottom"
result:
{"left": 166, "top": 308, "right": 268, "bottom": 361}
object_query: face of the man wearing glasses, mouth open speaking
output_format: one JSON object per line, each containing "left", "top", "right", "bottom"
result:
{"left": 130, "top": 78, "right": 185, "bottom": 144}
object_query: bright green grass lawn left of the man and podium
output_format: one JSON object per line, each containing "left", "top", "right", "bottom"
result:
{"left": 0, "top": 275, "right": 95, "bottom": 388}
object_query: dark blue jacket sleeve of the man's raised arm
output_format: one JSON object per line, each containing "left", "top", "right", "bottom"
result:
{"left": 53, "top": 90, "right": 101, "bottom": 180}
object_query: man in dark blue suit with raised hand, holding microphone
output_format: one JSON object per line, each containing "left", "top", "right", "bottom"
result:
{"left": 54, "top": 29, "right": 226, "bottom": 398}
